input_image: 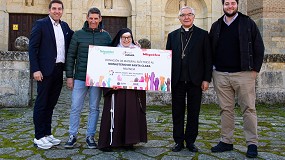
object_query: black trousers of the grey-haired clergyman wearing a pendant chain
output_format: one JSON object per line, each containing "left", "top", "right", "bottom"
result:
{"left": 172, "top": 81, "right": 202, "bottom": 145}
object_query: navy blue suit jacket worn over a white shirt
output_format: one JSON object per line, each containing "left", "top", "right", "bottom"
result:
{"left": 29, "top": 16, "right": 73, "bottom": 76}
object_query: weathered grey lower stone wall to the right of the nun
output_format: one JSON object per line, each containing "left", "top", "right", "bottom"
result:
{"left": 147, "top": 57, "right": 285, "bottom": 105}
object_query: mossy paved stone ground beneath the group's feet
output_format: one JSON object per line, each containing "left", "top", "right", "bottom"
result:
{"left": 0, "top": 83, "right": 285, "bottom": 160}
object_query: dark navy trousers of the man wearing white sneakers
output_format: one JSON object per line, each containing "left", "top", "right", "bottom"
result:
{"left": 33, "top": 65, "right": 63, "bottom": 139}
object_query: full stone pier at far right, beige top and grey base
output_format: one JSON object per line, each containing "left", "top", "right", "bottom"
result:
{"left": 247, "top": 0, "right": 285, "bottom": 103}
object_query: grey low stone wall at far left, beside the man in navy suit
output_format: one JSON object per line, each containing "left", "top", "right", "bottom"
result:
{"left": 0, "top": 51, "right": 31, "bottom": 107}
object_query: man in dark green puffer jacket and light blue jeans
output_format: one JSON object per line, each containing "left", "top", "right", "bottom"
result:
{"left": 64, "top": 8, "right": 112, "bottom": 148}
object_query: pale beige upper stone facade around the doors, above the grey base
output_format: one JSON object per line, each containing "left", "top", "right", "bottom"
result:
{"left": 0, "top": 0, "right": 285, "bottom": 54}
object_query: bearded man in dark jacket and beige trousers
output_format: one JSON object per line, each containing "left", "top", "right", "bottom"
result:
{"left": 206, "top": 0, "right": 264, "bottom": 158}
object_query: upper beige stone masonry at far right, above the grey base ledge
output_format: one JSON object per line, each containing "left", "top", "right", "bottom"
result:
{"left": 248, "top": 0, "right": 285, "bottom": 54}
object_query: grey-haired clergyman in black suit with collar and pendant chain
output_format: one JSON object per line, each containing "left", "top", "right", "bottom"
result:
{"left": 166, "top": 6, "right": 212, "bottom": 152}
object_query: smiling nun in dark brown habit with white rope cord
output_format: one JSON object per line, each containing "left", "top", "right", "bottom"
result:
{"left": 98, "top": 28, "right": 147, "bottom": 152}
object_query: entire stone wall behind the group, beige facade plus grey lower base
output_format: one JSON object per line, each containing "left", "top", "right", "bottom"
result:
{"left": 0, "top": 0, "right": 285, "bottom": 106}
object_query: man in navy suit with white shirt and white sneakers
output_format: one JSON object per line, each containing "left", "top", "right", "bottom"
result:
{"left": 29, "top": 0, "right": 73, "bottom": 149}
